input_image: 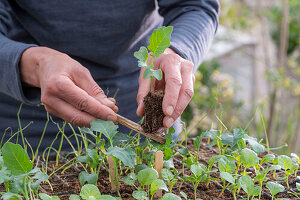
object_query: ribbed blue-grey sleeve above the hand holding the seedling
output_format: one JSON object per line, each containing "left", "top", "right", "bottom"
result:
{"left": 158, "top": 0, "right": 219, "bottom": 70}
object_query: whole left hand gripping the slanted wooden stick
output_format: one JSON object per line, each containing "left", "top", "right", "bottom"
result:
{"left": 20, "top": 47, "right": 118, "bottom": 127}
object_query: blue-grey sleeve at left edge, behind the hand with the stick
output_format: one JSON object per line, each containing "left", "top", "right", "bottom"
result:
{"left": 0, "top": 1, "right": 40, "bottom": 105}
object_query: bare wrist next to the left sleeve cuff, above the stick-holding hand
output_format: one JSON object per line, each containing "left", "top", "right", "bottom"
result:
{"left": 19, "top": 47, "right": 59, "bottom": 87}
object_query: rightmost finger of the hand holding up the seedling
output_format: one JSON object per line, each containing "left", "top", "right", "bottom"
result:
{"left": 164, "top": 61, "right": 194, "bottom": 128}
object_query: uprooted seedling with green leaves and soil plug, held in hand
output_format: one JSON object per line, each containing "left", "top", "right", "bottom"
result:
{"left": 134, "top": 26, "right": 173, "bottom": 133}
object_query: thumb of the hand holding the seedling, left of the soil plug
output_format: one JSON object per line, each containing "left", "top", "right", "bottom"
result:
{"left": 136, "top": 68, "right": 151, "bottom": 117}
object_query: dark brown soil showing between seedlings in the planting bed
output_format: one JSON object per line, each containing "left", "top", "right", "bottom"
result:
{"left": 0, "top": 140, "right": 300, "bottom": 200}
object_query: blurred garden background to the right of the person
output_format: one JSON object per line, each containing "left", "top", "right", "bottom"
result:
{"left": 182, "top": 0, "right": 300, "bottom": 154}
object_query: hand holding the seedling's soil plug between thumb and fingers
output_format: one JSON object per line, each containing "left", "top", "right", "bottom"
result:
{"left": 137, "top": 48, "right": 195, "bottom": 128}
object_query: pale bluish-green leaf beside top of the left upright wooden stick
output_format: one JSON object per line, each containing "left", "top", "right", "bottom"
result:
{"left": 107, "top": 147, "right": 136, "bottom": 167}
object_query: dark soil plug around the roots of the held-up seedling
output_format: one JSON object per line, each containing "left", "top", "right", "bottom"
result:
{"left": 142, "top": 90, "right": 165, "bottom": 133}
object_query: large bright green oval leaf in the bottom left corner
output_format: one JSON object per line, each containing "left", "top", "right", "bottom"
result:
{"left": 1, "top": 142, "right": 33, "bottom": 175}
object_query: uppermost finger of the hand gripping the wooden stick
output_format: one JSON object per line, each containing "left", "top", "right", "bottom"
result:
{"left": 72, "top": 66, "right": 115, "bottom": 109}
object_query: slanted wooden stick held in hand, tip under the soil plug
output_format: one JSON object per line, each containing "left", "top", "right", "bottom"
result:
{"left": 117, "top": 114, "right": 166, "bottom": 144}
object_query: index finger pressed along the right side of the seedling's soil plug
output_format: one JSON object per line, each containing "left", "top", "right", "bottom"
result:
{"left": 159, "top": 55, "right": 182, "bottom": 116}
